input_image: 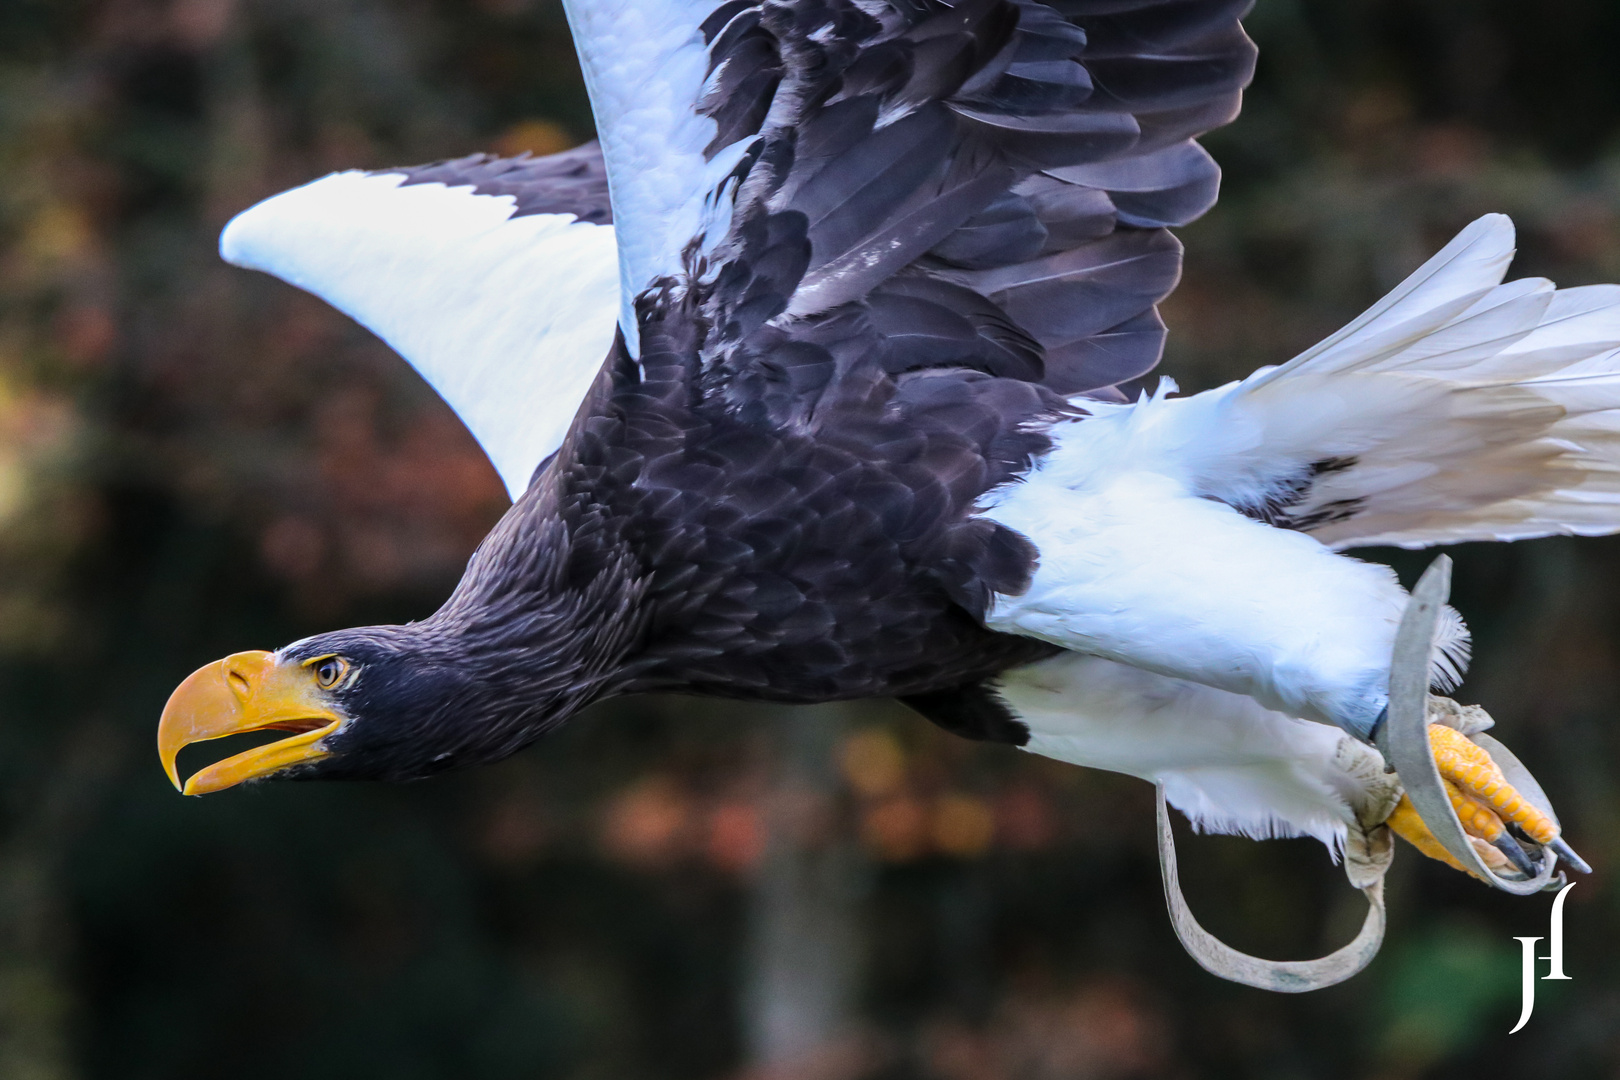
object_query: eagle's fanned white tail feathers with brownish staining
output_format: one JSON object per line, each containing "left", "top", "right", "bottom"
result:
{"left": 1187, "top": 215, "right": 1620, "bottom": 547}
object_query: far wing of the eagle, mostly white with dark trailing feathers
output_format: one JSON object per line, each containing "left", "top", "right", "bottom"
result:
{"left": 220, "top": 144, "right": 619, "bottom": 499}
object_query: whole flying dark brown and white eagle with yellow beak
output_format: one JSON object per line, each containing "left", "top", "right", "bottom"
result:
{"left": 157, "top": 0, "right": 1600, "bottom": 965}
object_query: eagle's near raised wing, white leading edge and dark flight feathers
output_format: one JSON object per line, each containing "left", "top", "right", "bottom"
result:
{"left": 567, "top": 0, "right": 1254, "bottom": 401}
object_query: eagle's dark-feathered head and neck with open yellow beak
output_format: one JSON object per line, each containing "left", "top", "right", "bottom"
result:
{"left": 157, "top": 484, "right": 645, "bottom": 795}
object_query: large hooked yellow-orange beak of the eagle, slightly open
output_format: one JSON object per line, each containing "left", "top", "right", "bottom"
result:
{"left": 157, "top": 651, "right": 343, "bottom": 795}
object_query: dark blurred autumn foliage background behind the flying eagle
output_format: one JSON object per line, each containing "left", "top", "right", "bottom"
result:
{"left": 0, "top": 0, "right": 1620, "bottom": 1080}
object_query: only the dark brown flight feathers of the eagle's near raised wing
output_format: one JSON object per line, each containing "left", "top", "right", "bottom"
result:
{"left": 708, "top": 0, "right": 1254, "bottom": 395}
